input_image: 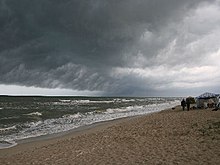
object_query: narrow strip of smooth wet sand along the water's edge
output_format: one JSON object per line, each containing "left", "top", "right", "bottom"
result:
{"left": 0, "top": 110, "right": 146, "bottom": 158}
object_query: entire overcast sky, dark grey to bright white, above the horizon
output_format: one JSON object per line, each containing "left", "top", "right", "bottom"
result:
{"left": 0, "top": 0, "right": 220, "bottom": 96}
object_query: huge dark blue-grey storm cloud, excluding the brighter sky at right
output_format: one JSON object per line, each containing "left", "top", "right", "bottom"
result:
{"left": 0, "top": 0, "right": 219, "bottom": 94}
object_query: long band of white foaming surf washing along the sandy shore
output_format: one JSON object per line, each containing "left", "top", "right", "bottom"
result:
{"left": 0, "top": 100, "right": 179, "bottom": 141}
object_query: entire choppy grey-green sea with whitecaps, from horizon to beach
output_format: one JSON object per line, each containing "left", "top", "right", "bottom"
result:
{"left": 0, "top": 96, "right": 180, "bottom": 149}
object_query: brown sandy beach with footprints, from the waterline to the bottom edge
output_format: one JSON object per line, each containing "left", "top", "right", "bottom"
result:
{"left": 0, "top": 107, "right": 220, "bottom": 165}
